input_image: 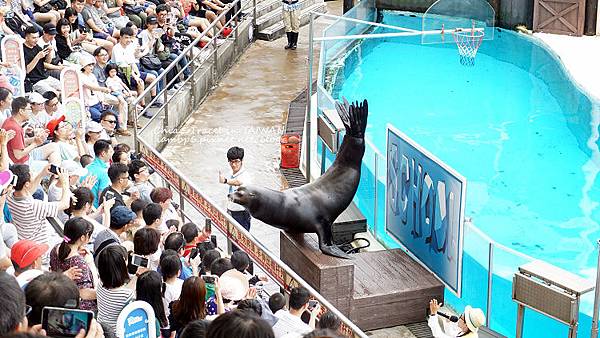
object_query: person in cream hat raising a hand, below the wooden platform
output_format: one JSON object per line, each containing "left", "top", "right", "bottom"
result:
{"left": 427, "top": 299, "right": 485, "bottom": 338}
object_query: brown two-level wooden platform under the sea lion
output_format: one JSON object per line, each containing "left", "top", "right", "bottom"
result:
{"left": 280, "top": 232, "right": 444, "bottom": 330}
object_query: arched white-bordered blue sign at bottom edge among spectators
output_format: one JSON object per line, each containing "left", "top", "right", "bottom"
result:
{"left": 117, "top": 301, "right": 156, "bottom": 338}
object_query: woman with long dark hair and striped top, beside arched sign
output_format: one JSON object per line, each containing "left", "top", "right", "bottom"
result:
{"left": 97, "top": 245, "right": 134, "bottom": 334}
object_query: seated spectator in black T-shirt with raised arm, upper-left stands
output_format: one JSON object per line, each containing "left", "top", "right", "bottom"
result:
{"left": 23, "top": 27, "right": 61, "bottom": 95}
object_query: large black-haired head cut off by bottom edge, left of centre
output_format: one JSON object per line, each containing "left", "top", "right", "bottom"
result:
{"left": 206, "top": 310, "right": 275, "bottom": 338}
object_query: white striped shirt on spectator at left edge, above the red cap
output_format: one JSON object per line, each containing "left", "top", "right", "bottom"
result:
{"left": 7, "top": 194, "right": 59, "bottom": 243}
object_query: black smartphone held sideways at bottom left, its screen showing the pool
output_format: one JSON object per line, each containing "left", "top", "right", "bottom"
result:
{"left": 42, "top": 306, "right": 94, "bottom": 337}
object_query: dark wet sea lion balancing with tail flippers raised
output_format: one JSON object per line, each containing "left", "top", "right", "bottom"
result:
{"left": 230, "top": 100, "right": 368, "bottom": 258}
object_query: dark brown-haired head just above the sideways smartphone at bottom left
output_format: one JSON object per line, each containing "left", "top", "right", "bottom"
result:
{"left": 25, "top": 272, "right": 79, "bottom": 326}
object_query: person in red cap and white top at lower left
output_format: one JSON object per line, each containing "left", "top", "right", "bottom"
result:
{"left": 10, "top": 239, "right": 49, "bottom": 288}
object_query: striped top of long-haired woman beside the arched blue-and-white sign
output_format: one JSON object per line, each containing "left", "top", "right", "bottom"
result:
{"left": 96, "top": 285, "right": 134, "bottom": 334}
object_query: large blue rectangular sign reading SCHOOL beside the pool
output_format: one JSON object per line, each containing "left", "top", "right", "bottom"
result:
{"left": 386, "top": 126, "right": 467, "bottom": 296}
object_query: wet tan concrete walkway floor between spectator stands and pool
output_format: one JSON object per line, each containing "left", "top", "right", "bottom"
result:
{"left": 163, "top": 0, "right": 414, "bottom": 338}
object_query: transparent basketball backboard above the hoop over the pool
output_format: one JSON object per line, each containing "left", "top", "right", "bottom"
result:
{"left": 421, "top": 0, "right": 496, "bottom": 44}
